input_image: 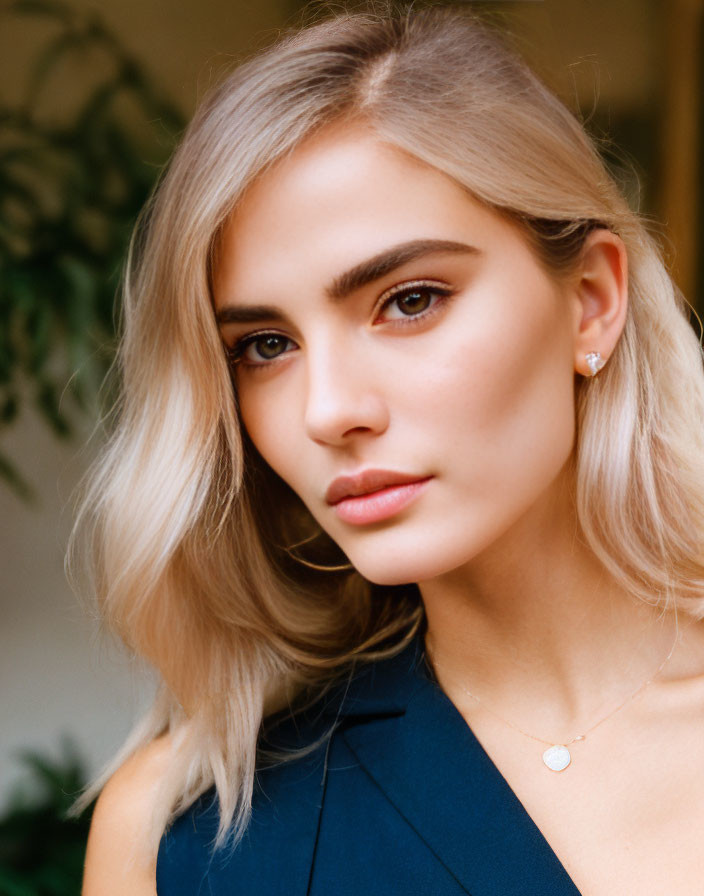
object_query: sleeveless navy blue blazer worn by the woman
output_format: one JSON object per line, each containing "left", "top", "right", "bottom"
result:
{"left": 157, "top": 632, "right": 579, "bottom": 896}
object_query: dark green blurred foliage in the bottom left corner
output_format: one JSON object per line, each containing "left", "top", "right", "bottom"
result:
{"left": 0, "top": 741, "right": 92, "bottom": 896}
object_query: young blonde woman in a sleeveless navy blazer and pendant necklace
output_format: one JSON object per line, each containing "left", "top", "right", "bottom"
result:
{"left": 73, "top": 8, "right": 704, "bottom": 896}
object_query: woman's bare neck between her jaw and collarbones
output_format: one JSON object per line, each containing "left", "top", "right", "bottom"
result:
{"left": 419, "top": 476, "right": 682, "bottom": 732}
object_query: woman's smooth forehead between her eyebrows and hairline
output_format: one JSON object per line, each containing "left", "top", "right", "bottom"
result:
{"left": 213, "top": 125, "right": 515, "bottom": 306}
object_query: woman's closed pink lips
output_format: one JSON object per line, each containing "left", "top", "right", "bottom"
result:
{"left": 325, "top": 470, "right": 433, "bottom": 525}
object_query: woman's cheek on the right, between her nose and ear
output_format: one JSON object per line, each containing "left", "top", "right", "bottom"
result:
{"left": 429, "top": 284, "right": 575, "bottom": 510}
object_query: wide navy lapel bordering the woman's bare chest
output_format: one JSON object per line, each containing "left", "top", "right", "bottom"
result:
{"left": 325, "top": 632, "right": 579, "bottom": 896}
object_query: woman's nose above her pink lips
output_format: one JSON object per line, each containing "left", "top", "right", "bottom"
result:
{"left": 304, "top": 341, "right": 389, "bottom": 447}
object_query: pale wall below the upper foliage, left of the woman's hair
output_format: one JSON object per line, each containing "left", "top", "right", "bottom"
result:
{"left": 0, "top": 400, "right": 157, "bottom": 806}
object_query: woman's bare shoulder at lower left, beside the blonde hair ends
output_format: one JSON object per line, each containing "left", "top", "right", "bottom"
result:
{"left": 82, "top": 735, "right": 171, "bottom": 896}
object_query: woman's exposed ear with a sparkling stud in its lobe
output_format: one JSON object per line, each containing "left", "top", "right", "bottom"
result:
{"left": 572, "top": 228, "right": 628, "bottom": 376}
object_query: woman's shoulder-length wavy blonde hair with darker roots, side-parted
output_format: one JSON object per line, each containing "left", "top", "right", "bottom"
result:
{"left": 69, "top": 1, "right": 704, "bottom": 860}
